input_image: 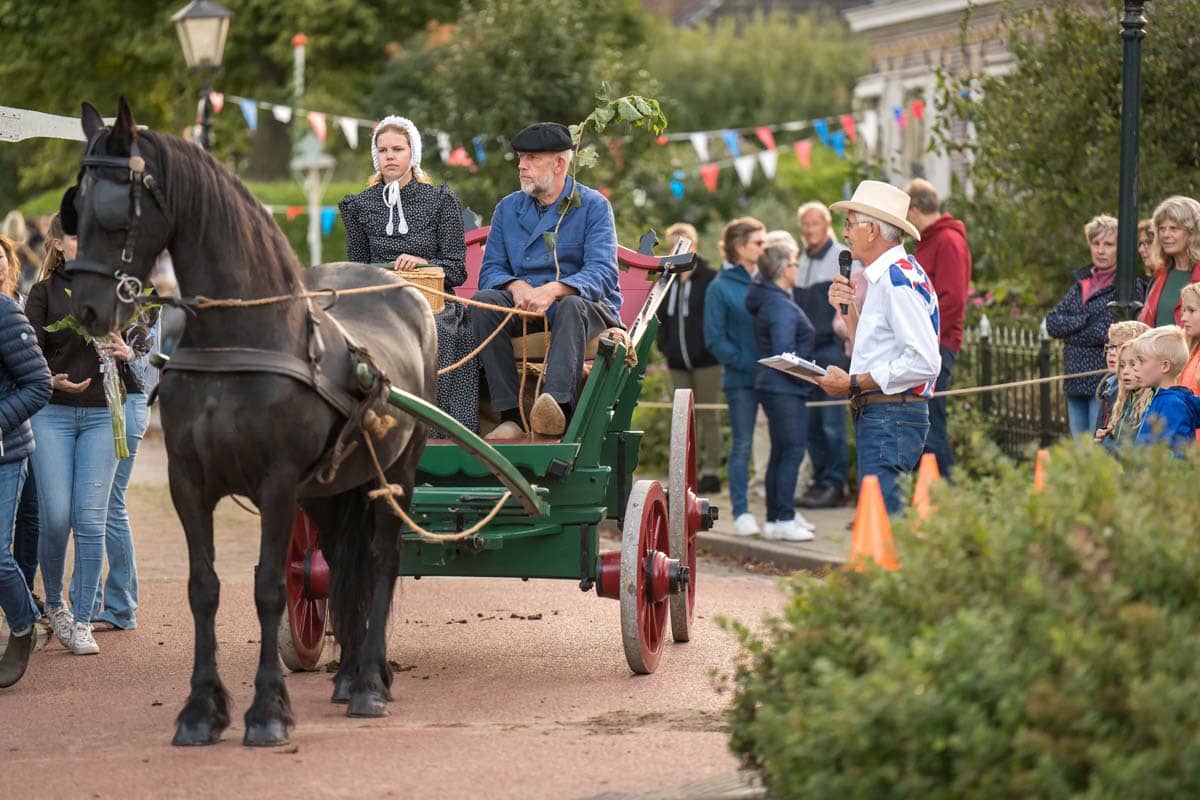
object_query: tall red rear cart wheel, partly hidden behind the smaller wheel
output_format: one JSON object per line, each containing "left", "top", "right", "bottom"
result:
{"left": 667, "top": 389, "right": 701, "bottom": 642}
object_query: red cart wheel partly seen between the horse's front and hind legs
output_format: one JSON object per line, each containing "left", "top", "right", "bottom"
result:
{"left": 280, "top": 509, "right": 329, "bottom": 672}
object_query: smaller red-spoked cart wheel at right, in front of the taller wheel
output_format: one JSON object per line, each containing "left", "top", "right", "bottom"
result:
{"left": 620, "top": 481, "right": 679, "bottom": 674}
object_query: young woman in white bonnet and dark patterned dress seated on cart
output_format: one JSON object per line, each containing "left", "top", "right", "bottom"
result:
{"left": 337, "top": 116, "right": 479, "bottom": 437}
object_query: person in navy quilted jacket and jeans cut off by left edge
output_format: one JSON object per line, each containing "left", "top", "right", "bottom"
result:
{"left": 0, "top": 267, "right": 50, "bottom": 688}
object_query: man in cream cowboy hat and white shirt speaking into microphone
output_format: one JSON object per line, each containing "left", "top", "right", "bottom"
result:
{"left": 817, "top": 181, "right": 942, "bottom": 515}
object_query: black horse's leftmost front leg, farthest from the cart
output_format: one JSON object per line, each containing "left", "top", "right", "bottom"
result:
{"left": 168, "top": 470, "right": 229, "bottom": 746}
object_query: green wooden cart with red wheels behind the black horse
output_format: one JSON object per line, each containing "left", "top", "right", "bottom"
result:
{"left": 280, "top": 228, "right": 716, "bottom": 673}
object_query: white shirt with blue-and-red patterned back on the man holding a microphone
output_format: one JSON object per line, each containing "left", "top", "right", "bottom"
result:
{"left": 850, "top": 245, "right": 942, "bottom": 397}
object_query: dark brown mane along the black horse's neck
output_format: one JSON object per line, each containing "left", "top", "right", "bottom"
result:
{"left": 145, "top": 131, "right": 301, "bottom": 290}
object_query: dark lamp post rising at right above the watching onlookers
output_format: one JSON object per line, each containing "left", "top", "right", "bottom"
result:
{"left": 1109, "top": 0, "right": 1150, "bottom": 319}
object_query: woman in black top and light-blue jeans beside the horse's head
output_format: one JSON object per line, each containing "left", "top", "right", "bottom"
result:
{"left": 25, "top": 211, "right": 132, "bottom": 655}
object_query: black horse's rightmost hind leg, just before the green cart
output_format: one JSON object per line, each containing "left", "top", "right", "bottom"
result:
{"left": 346, "top": 425, "right": 427, "bottom": 717}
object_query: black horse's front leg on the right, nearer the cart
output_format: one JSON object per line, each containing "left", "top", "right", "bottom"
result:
{"left": 241, "top": 475, "right": 296, "bottom": 747}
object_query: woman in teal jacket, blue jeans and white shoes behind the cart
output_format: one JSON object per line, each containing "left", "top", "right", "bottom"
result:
{"left": 704, "top": 217, "right": 767, "bottom": 536}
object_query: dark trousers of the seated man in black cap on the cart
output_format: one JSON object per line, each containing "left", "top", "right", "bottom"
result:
{"left": 470, "top": 289, "right": 620, "bottom": 411}
